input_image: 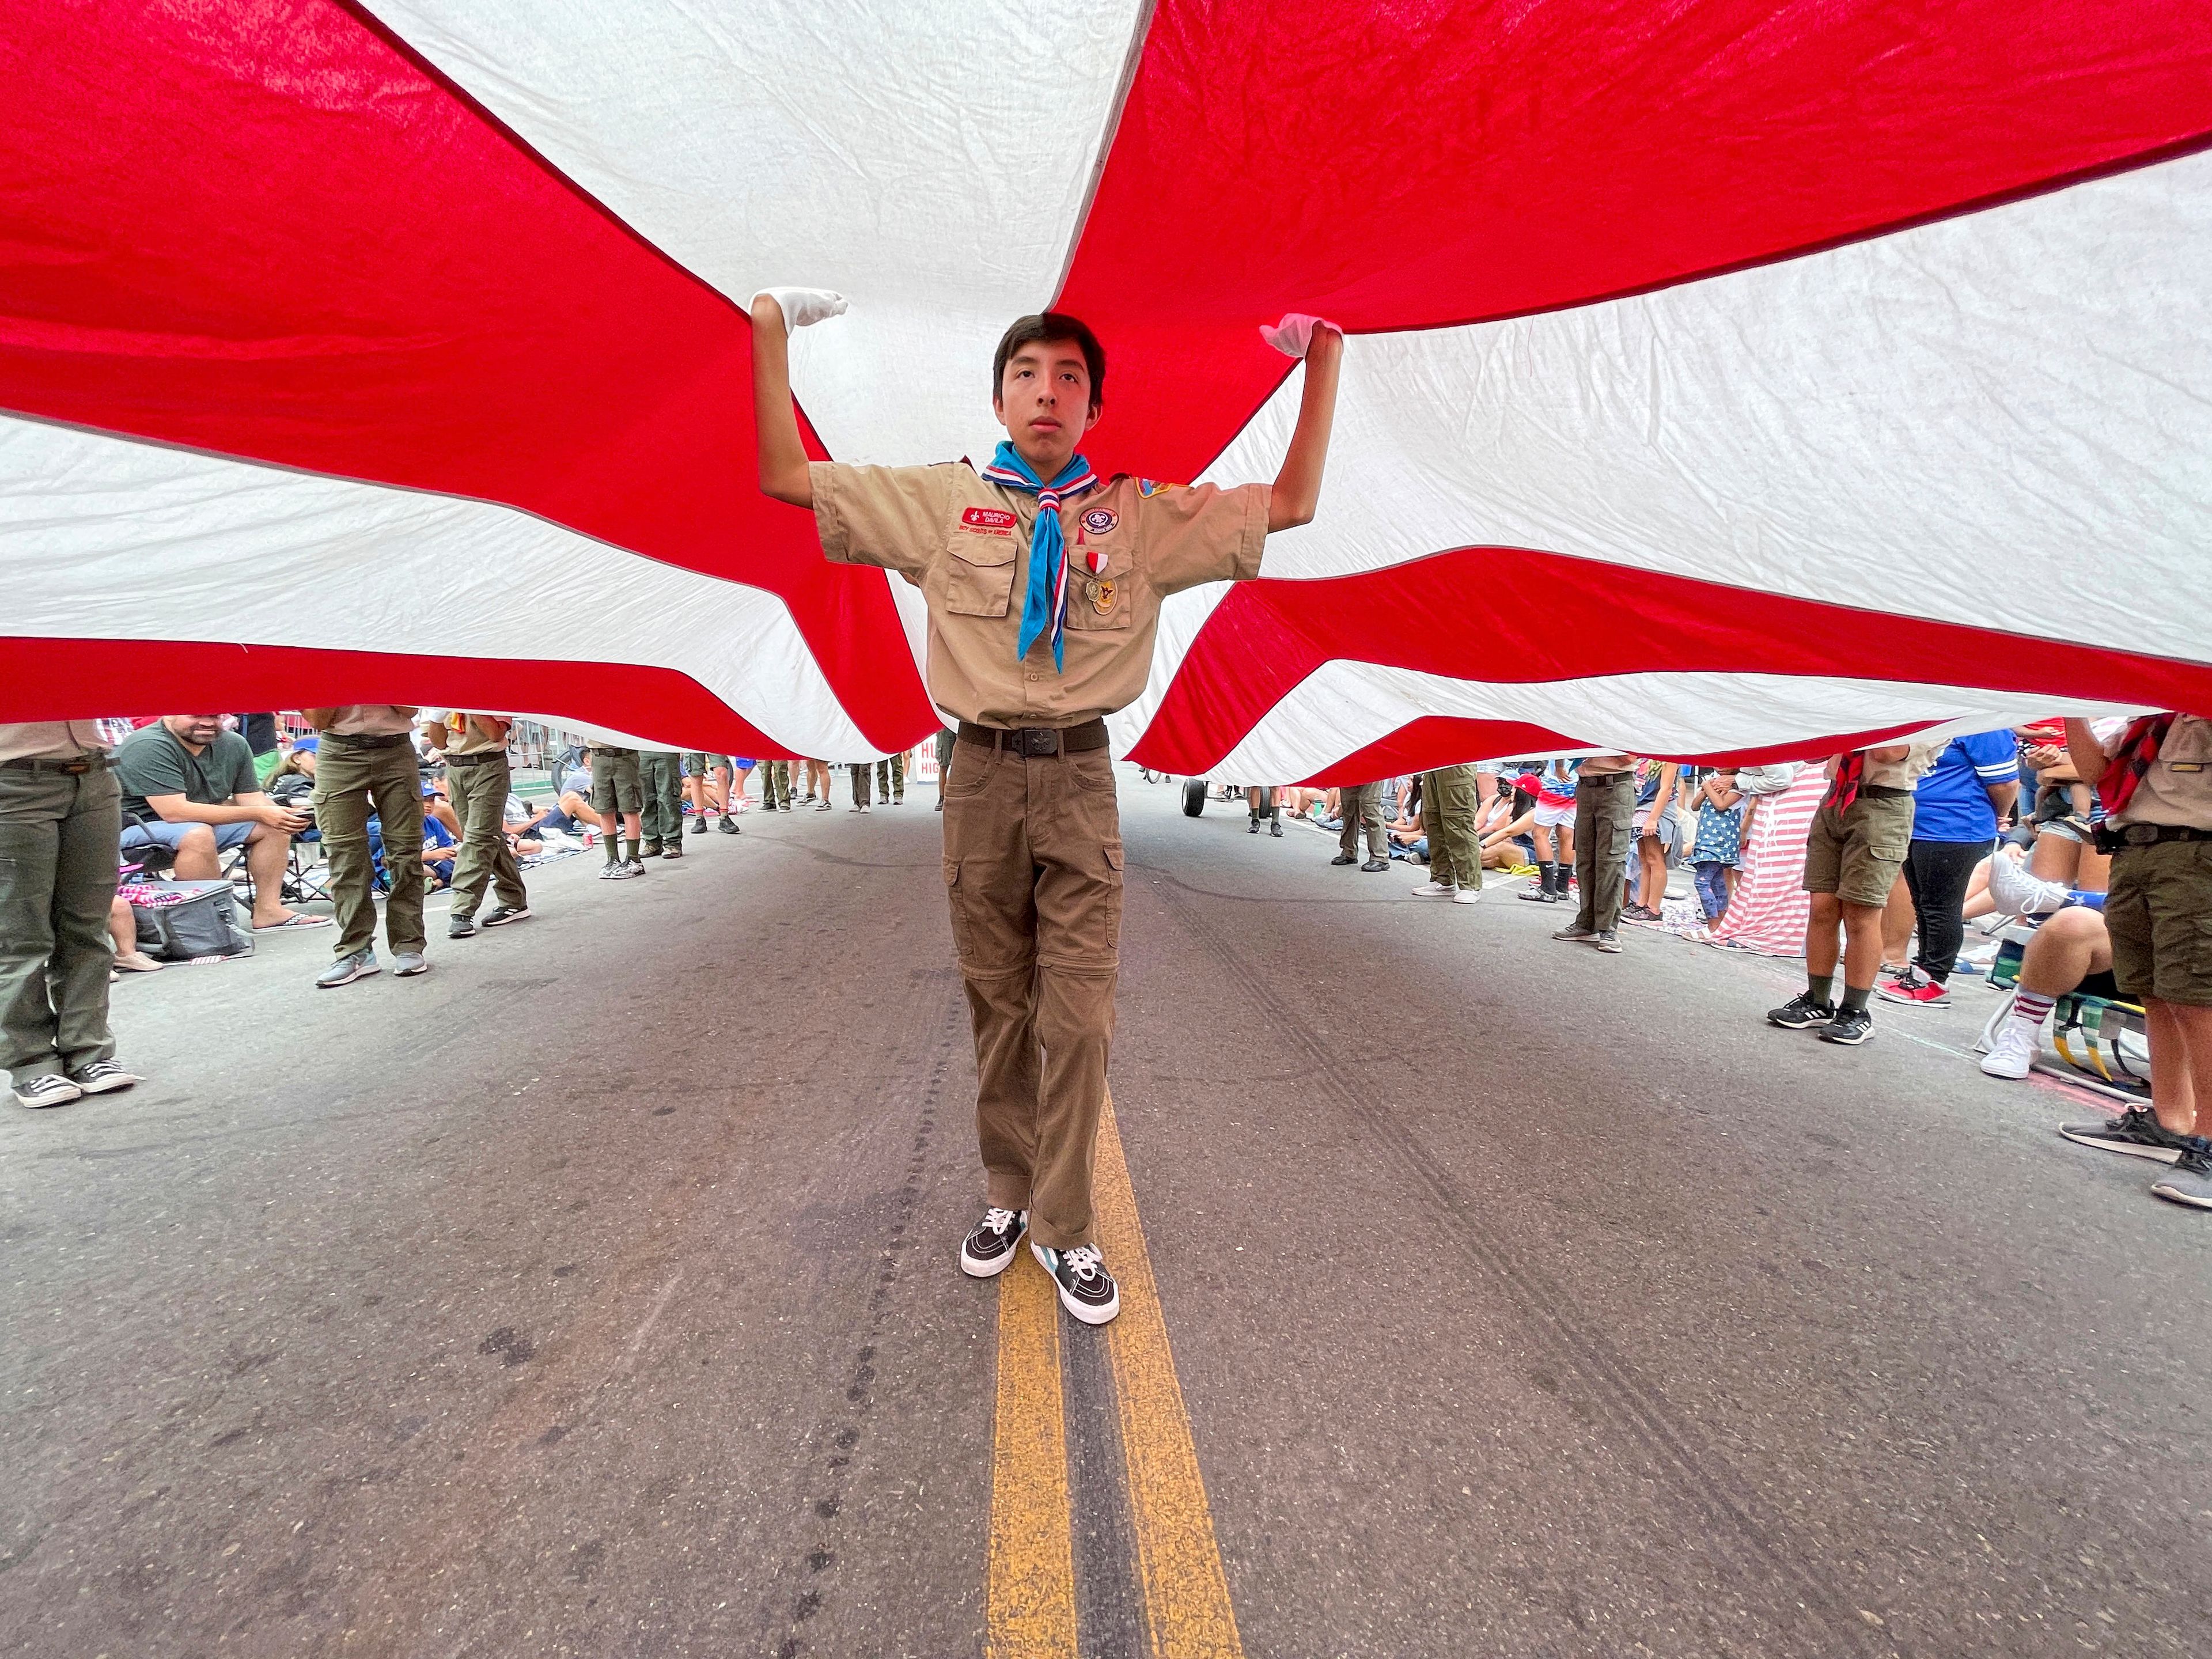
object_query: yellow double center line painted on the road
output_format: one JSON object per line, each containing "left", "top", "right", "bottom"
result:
{"left": 984, "top": 1099, "right": 1243, "bottom": 1659}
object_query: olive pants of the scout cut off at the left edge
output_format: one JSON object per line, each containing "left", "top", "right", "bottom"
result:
{"left": 0, "top": 763, "right": 122, "bottom": 1084}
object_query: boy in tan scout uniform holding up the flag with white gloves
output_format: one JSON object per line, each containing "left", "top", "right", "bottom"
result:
{"left": 752, "top": 290, "right": 1343, "bottom": 1325}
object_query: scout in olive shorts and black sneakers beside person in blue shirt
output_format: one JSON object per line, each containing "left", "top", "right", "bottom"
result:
{"left": 1767, "top": 743, "right": 1944, "bottom": 1044}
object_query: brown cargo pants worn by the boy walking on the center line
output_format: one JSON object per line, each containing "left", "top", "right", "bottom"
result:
{"left": 945, "top": 741, "right": 1122, "bottom": 1250}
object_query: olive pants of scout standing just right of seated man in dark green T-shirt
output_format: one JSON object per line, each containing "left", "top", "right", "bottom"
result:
{"left": 314, "top": 732, "right": 422, "bottom": 956}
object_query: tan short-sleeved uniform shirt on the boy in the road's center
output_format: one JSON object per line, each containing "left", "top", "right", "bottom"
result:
{"left": 808, "top": 460, "right": 1267, "bottom": 726}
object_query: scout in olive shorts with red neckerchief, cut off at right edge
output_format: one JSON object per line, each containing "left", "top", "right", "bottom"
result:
{"left": 2059, "top": 714, "right": 2212, "bottom": 1210}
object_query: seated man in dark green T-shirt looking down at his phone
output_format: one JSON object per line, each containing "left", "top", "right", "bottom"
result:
{"left": 115, "top": 714, "right": 329, "bottom": 929}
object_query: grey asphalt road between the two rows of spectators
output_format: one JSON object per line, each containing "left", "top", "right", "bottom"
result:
{"left": 0, "top": 774, "right": 2212, "bottom": 1659}
